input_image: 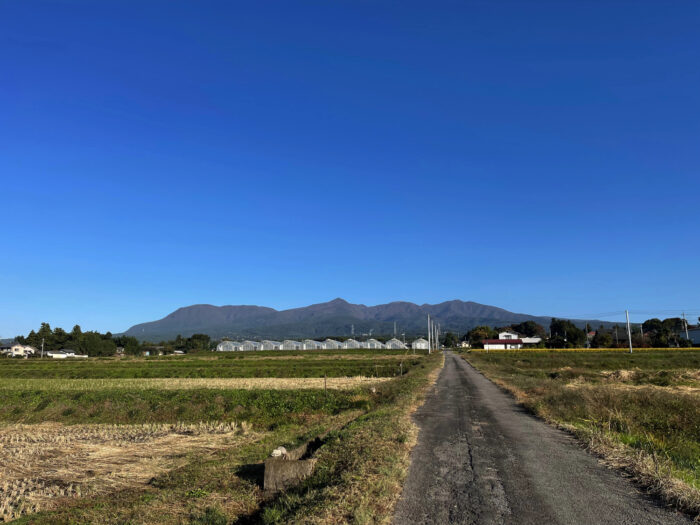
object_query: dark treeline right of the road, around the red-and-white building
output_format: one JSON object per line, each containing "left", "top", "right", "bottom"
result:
{"left": 460, "top": 317, "right": 700, "bottom": 348}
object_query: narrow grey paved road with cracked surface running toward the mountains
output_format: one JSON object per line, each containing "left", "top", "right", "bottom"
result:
{"left": 394, "top": 352, "right": 691, "bottom": 525}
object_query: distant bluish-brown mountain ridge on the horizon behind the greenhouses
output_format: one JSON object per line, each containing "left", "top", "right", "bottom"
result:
{"left": 125, "top": 298, "right": 598, "bottom": 341}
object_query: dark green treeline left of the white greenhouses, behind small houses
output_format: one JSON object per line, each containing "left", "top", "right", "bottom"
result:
{"left": 15, "top": 323, "right": 213, "bottom": 357}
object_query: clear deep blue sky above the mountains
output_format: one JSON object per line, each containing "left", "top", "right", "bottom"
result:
{"left": 0, "top": 0, "right": 700, "bottom": 337}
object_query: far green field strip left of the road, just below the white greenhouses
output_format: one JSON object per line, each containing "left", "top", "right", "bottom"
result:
{"left": 0, "top": 350, "right": 421, "bottom": 379}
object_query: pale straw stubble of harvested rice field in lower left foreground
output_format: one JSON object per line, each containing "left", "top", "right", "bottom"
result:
{"left": 0, "top": 423, "right": 252, "bottom": 521}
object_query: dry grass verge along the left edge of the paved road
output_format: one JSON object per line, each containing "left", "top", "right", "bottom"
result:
{"left": 260, "top": 353, "right": 444, "bottom": 524}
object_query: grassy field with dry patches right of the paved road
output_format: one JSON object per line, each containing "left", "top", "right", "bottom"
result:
{"left": 462, "top": 350, "right": 700, "bottom": 514}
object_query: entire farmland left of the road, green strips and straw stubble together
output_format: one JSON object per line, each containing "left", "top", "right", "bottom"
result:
{"left": 0, "top": 351, "right": 442, "bottom": 524}
